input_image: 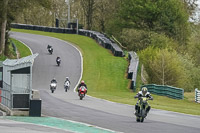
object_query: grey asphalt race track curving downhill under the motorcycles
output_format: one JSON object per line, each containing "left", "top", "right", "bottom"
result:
{"left": 11, "top": 32, "right": 200, "bottom": 133}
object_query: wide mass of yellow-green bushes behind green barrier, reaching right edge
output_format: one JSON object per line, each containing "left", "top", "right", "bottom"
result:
{"left": 139, "top": 47, "right": 200, "bottom": 91}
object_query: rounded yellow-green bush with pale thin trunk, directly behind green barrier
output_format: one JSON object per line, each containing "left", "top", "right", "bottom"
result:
{"left": 149, "top": 49, "right": 185, "bottom": 86}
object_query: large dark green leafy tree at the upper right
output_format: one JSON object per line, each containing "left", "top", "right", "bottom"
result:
{"left": 119, "top": 0, "right": 190, "bottom": 45}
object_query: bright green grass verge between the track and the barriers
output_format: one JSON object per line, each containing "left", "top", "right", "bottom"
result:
{"left": 12, "top": 29, "right": 200, "bottom": 115}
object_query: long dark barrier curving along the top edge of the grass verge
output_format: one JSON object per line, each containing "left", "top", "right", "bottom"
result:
{"left": 11, "top": 23, "right": 124, "bottom": 57}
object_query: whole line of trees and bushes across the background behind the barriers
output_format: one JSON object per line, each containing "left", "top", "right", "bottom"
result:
{"left": 0, "top": 0, "right": 200, "bottom": 91}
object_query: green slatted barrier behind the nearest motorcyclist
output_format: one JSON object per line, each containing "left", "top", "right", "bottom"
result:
{"left": 142, "top": 84, "right": 184, "bottom": 99}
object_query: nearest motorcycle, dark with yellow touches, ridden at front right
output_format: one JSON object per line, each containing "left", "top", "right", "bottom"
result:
{"left": 135, "top": 97, "right": 151, "bottom": 122}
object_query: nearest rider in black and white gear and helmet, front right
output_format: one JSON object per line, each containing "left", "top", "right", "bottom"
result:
{"left": 134, "top": 87, "right": 153, "bottom": 114}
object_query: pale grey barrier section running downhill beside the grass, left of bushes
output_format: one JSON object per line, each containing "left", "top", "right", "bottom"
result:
{"left": 128, "top": 51, "right": 139, "bottom": 91}
